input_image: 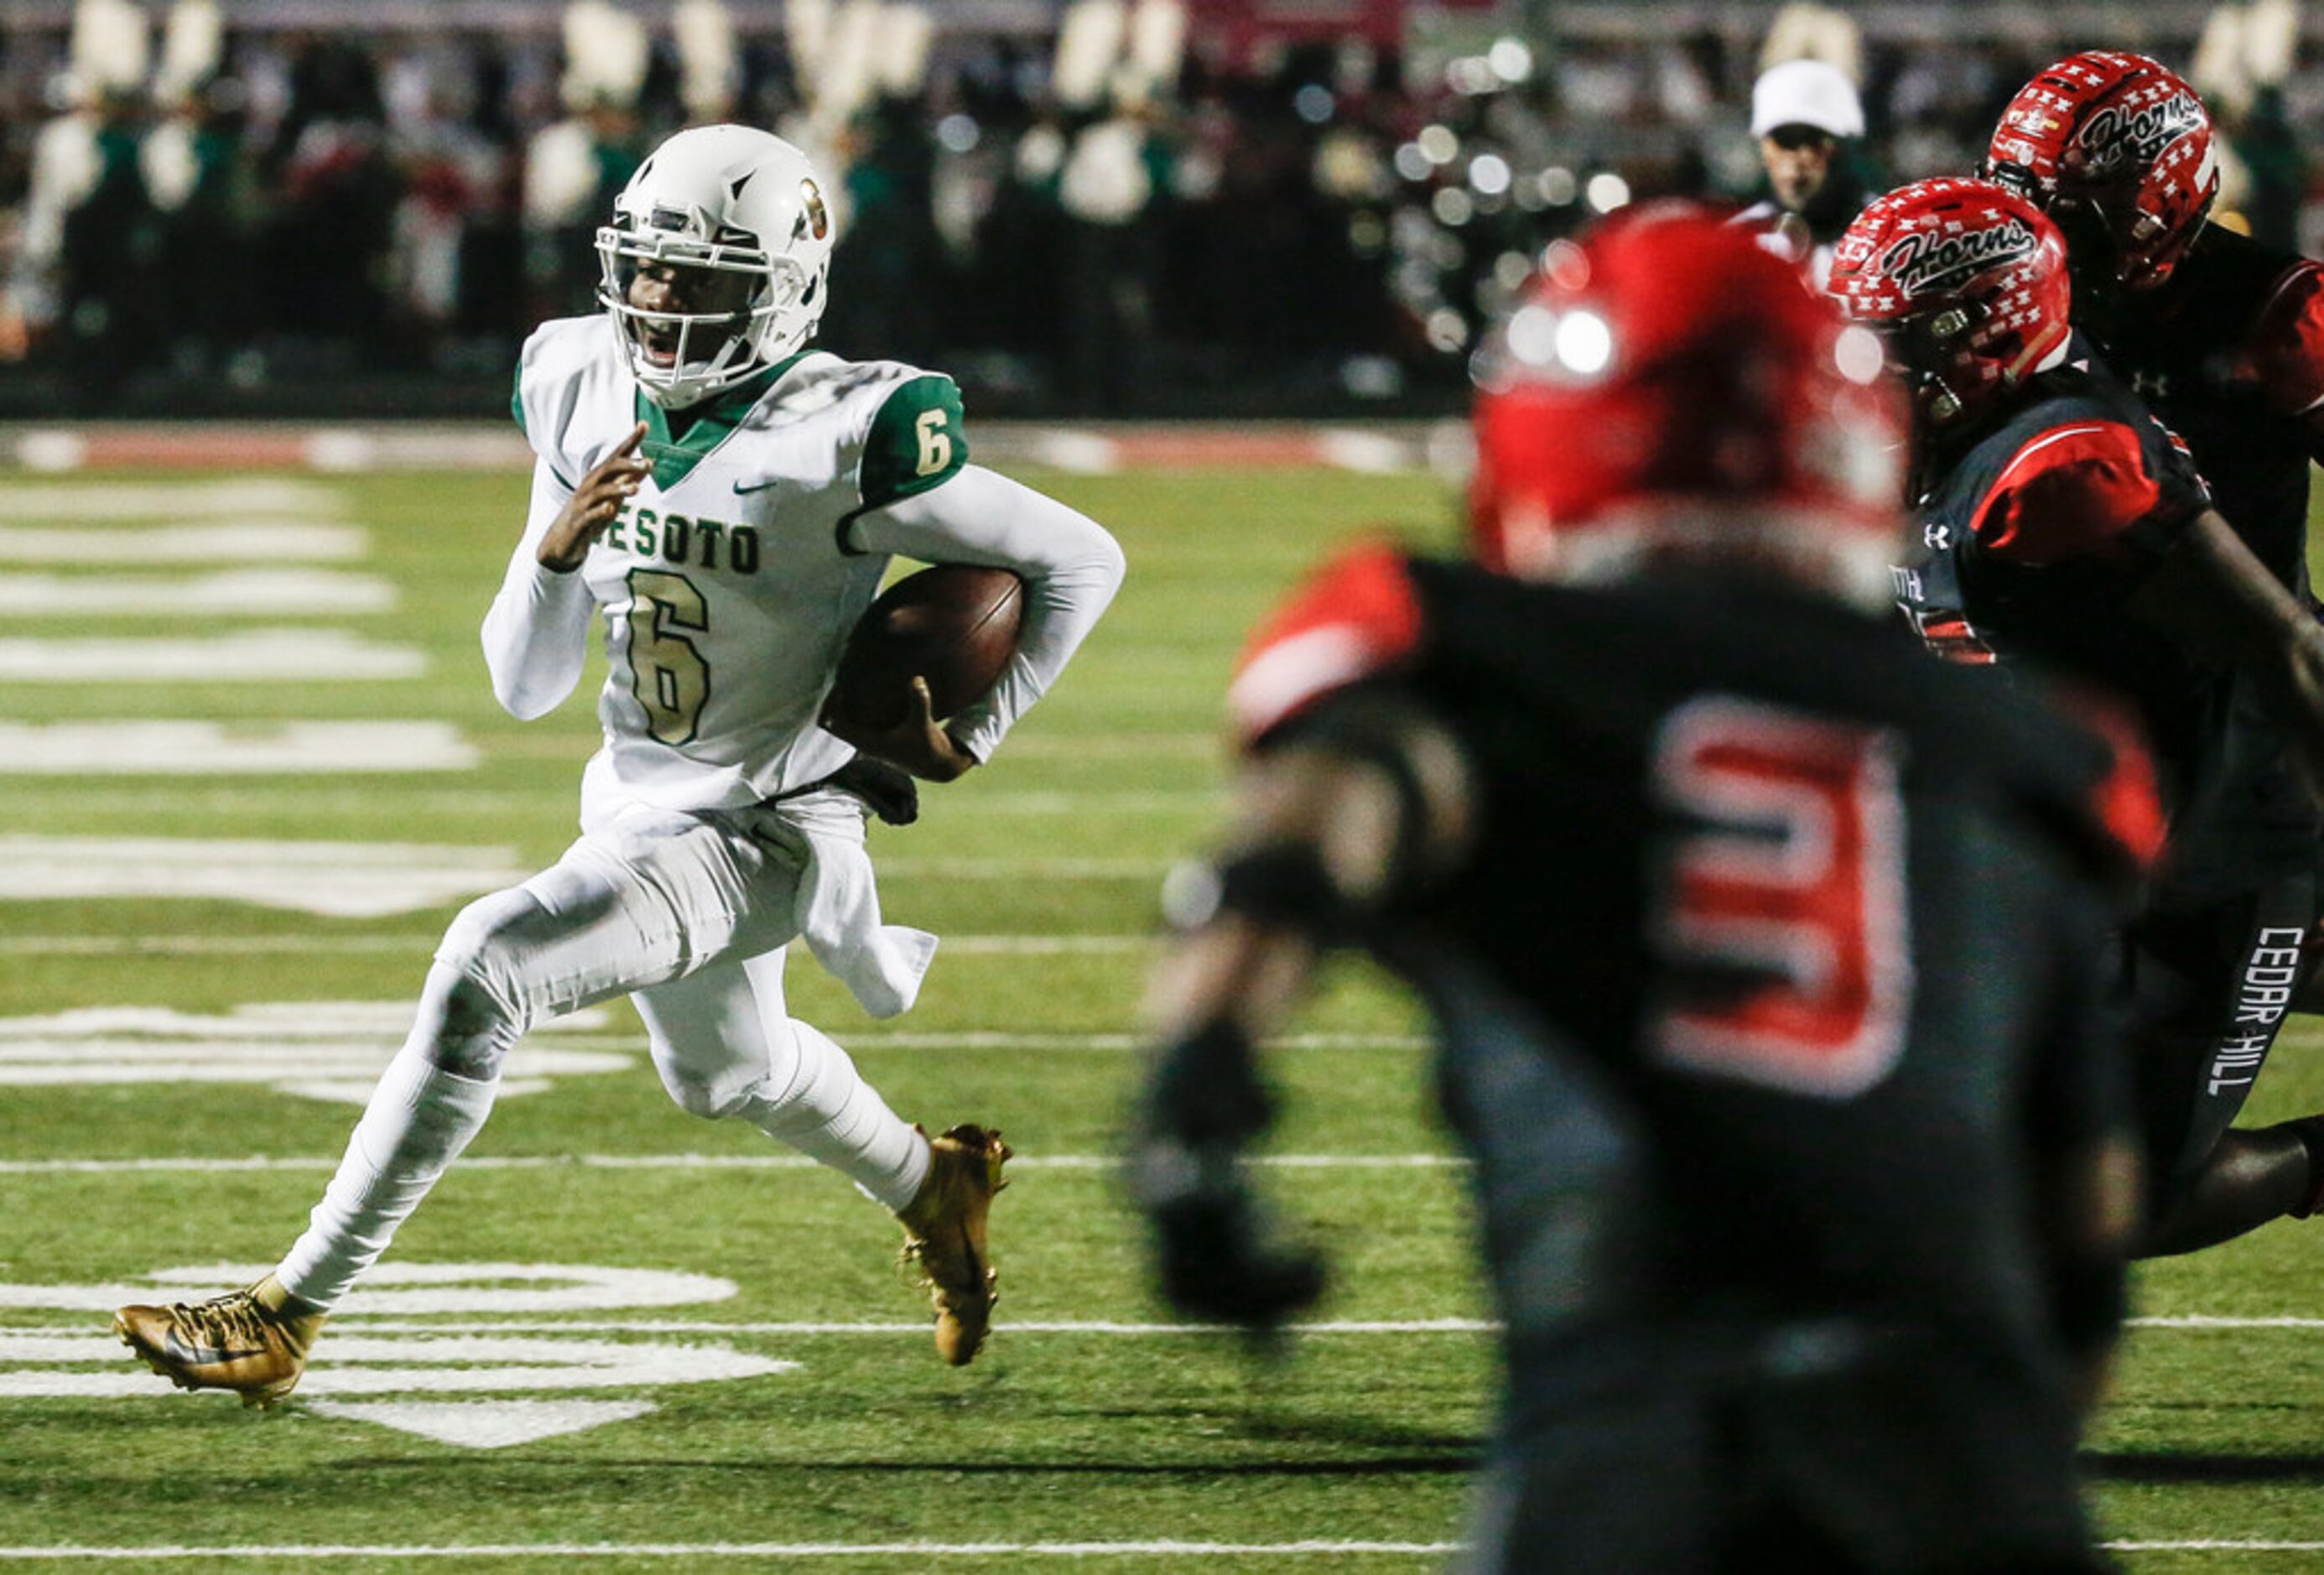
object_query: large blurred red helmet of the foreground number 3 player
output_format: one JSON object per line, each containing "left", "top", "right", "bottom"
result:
{"left": 1471, "top": 202, "right": 1903, "bottom": 597}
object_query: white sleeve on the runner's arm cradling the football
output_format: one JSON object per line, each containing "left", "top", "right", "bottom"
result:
{"left": 848, "top": 465, "right": 1122, "bottom": 760}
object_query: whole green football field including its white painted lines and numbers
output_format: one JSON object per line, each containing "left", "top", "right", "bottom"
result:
{"left": 0, "top": 457, "right": 2324, "bottom": 1570}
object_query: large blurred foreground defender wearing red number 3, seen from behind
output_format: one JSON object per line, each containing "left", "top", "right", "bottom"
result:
{"left": 1131, "top": 211, "right": 2161, "bottom": 1572}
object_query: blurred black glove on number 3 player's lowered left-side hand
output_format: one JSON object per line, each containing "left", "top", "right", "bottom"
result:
{"left": 1130, "top": 1022, "right": 1324, "bottom": 1328}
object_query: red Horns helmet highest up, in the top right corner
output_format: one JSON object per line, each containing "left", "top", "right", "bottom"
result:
{"left": 1984, "top": 49, "right": 2219, "bottom": 290}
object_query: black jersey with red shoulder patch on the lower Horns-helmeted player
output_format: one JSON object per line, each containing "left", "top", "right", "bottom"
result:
{"left": 1896, "top": 351, "right": 2317, "bottom": 903}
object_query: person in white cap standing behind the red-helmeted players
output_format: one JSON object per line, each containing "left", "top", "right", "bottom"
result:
{"left": 1736, "top": 60, "right": 1866, "bottom": 286}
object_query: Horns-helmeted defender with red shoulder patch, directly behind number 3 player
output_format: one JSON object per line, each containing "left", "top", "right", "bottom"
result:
{"left": 1832, "top": 181, "right": 2324, "bottom": 1255}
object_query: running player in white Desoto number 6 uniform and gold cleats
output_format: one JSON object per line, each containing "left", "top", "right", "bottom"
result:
{"left": 117, "top": 126, "right": 1122, "bottom": 1403}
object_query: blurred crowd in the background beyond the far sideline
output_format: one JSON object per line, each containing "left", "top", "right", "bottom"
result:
{"left": 0, "top": 0, "right": 2324, "bottom": 416}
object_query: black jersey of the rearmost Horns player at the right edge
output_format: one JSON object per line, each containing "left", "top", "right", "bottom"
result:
{"left": 2094, "top": 226, "right": 2324, "bottom": 590}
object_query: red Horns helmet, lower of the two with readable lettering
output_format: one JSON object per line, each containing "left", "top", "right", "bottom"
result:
{"left": 1824, "top": 179, "right": 2073, "bottom": 420}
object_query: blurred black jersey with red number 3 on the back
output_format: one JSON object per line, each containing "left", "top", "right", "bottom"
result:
{"left": 1230, "top": 550, "right": 2159, "bottom": 1370}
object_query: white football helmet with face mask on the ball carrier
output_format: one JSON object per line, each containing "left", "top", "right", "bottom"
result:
{"left": 597, "top": 126, "right": 832, "bottom": 409}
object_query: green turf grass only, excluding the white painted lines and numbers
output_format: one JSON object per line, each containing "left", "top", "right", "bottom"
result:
{"left": 13, "top": 460, "right": 2324, "bottom": 1572}
